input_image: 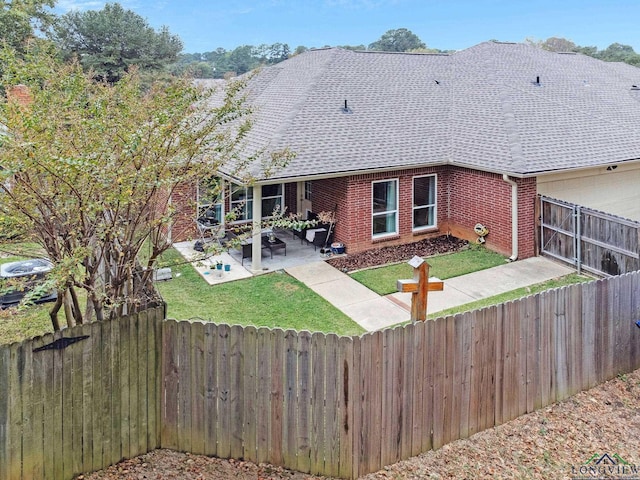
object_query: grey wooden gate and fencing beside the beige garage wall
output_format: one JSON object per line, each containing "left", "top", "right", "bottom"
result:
{"left": 539, "top": 196, "right": 640, "bottom": 275}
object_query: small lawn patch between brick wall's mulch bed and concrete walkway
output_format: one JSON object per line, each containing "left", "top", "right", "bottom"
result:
{"left": 351, "top": 246, "right": 506, "bottom": 295}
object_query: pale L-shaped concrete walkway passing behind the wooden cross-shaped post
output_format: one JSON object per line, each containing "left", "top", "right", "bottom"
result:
{"left": 286, "top": 257, "right": 575, "bottom": 331}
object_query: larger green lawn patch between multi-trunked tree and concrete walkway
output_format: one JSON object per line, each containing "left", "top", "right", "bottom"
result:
{"left": 157, "top": 249, "right": 364, "bottom": 336}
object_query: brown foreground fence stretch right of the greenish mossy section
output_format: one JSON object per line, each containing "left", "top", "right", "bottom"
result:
{"left": 161, "top": 272, "right": 640, "bottom": 478}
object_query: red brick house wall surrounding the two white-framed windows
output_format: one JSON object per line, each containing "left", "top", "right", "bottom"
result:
{"left": 313, "top": 167, "right": 536, "bottom": 258}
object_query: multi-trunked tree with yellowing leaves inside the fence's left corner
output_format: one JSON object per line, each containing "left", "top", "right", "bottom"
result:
{"left": 0, "top": 45, "right": 289, "bottom": 329}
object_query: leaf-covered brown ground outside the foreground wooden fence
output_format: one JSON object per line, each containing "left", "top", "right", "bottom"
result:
{"left": 78, "top": 370, "right": 640, "bottom": 480}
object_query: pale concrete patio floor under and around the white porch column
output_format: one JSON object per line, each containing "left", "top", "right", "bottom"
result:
{"left": 173, "top": 229, "right": 334, "bottom": 285}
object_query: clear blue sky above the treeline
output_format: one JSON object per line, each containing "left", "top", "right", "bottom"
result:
{"left": 56, "top": 0, "right": 640, "bottom": 53}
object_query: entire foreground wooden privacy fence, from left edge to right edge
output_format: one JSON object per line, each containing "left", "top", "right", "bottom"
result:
{"left": 0, "top": 272, "right": 640, "bottom": 480}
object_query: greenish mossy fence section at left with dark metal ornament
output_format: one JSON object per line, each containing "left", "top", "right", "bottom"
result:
{"left": 0, "top": 308, "right": 164, "bottom": 480}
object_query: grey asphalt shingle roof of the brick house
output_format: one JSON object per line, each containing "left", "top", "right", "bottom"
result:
{"left": 214, "top": 42, "right": 640, "bottom": 179}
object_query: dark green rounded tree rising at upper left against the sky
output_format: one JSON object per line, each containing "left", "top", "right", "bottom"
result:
{"left": 51, "top": 3, "right": 182, "bottom": 83}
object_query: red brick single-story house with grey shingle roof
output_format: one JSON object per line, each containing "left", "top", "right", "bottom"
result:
{"left": 170, "top": 42, "right": 640, "bottom": 270}
